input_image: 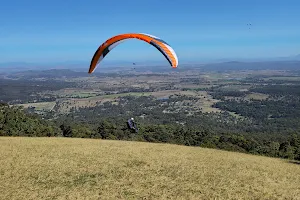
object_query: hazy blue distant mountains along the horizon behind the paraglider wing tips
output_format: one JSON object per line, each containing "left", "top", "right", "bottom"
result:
{"left": 0, "top": 54, "right": 300, "bottom": 73}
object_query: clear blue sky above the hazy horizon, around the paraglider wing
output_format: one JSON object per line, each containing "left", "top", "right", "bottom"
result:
{"left": 0, "top": 0, "right": 300, "bottom": 62}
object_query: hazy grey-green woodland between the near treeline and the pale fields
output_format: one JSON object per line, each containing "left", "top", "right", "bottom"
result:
{"left": 48, "top": 95, "right": 300, "bottom": 140}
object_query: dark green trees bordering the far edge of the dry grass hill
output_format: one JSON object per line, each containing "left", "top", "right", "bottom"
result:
{"left": 0, "top": 100, "right": 300, "bottom": 160}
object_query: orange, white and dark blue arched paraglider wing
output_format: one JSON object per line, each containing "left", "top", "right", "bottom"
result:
{"left": 89, "top": 33, "right": 178, "bottom": 73}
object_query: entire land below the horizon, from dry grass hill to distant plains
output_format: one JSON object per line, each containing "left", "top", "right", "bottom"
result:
{"left": 0, "top": 61, "right": 300, "bottom": 199}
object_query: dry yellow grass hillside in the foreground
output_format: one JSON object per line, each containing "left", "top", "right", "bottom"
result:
{"left": 0, "top": 137, "right": 300, "bottom": 199}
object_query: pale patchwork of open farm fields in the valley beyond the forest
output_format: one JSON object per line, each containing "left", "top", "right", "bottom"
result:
{"left": 14, "top": 70, "right": 299, "bottom": 116}
